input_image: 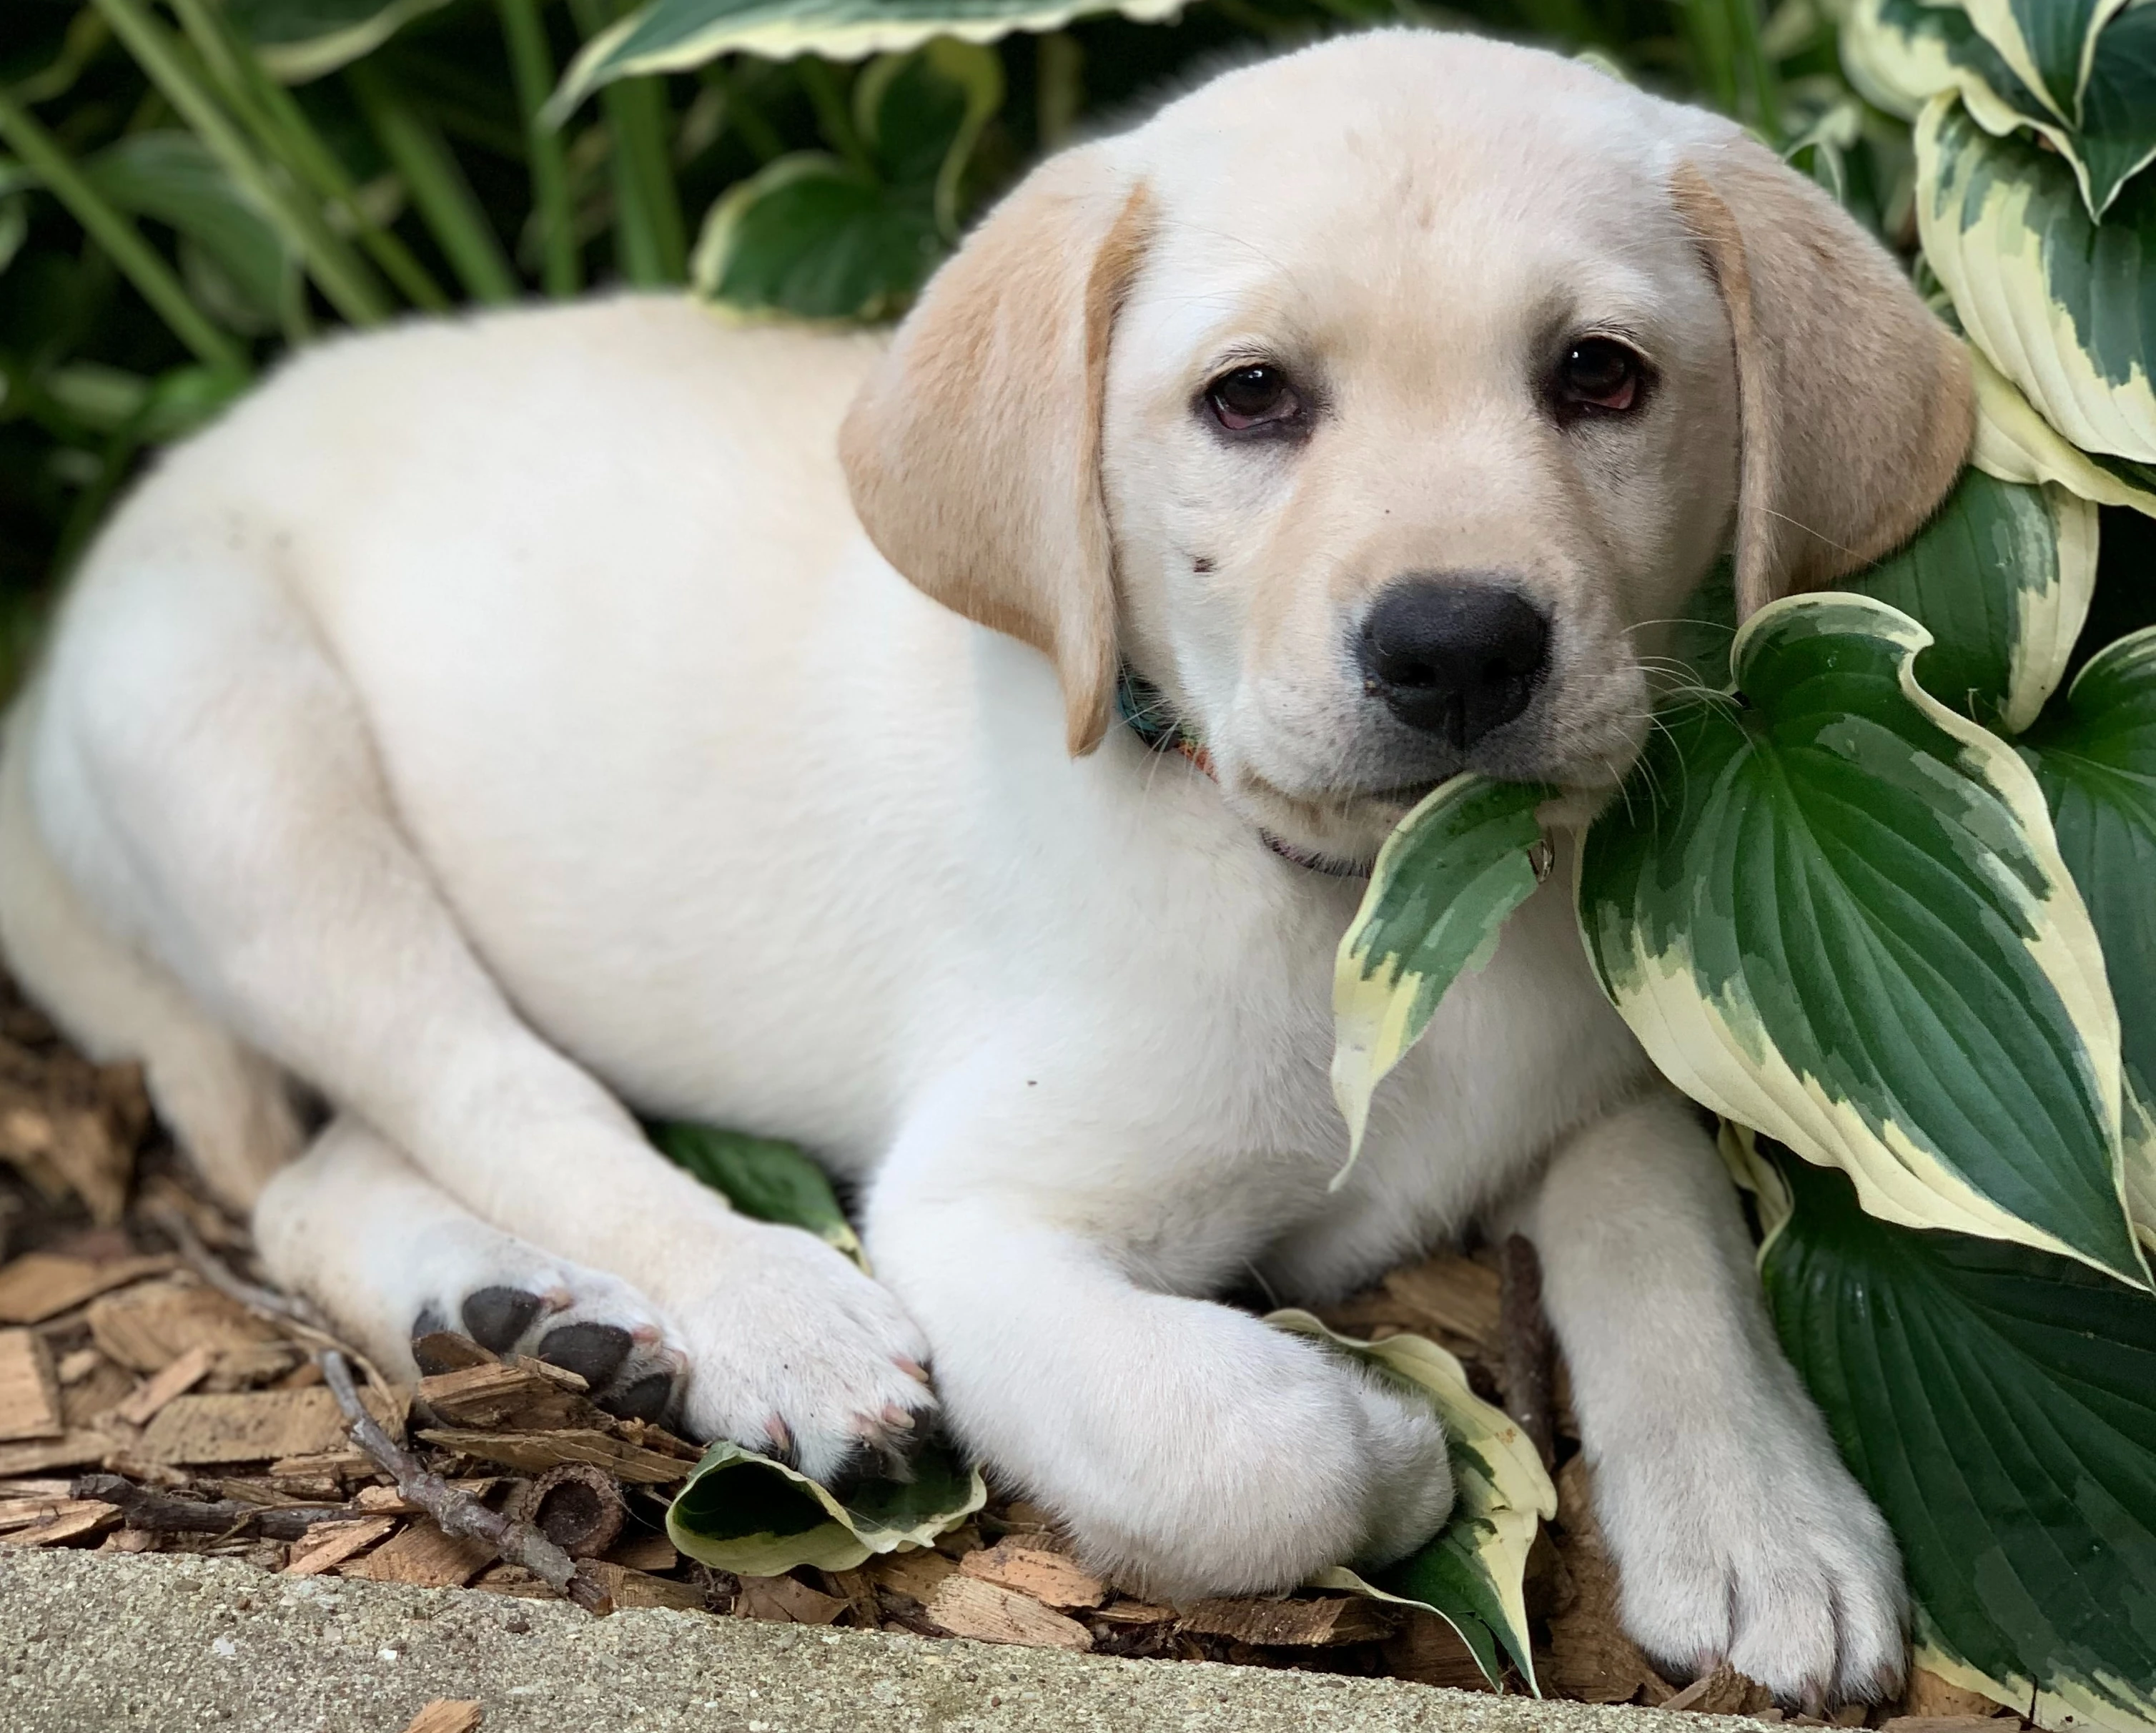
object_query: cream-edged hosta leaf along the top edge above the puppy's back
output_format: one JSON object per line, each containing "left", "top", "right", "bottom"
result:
{"left": 545, "top": 0, "right": 1186, "bottom": 125}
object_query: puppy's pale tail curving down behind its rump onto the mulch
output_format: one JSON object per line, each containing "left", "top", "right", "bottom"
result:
{"left": 0, "top": 681, "right": 304, "bottom": 1211}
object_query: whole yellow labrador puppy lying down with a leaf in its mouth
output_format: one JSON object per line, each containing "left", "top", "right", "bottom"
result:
{"left": 0, "top": 32, "right": 1971, "bottom": 1699}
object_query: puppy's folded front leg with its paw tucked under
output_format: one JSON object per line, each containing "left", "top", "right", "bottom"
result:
{"left": 869, "top": 1175, "right": 1453, "bottom": 1599}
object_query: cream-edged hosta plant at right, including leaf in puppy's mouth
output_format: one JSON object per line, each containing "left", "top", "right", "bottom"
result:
{"left": 1335, "top": 20, "right": 2156, "bottom": 1707}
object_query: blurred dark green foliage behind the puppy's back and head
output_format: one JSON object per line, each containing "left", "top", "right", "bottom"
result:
{"left": 0, "top": 0, "right": 1889, "bottom": 690}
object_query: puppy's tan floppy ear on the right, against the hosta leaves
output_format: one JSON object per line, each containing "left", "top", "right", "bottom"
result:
{"left": 1671, "top": 138, "right": 1975, "bottom": 618}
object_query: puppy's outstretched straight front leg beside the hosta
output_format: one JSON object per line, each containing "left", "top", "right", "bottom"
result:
{"left": 1518, "top": 1095, "right": 1906, "bottom": 1703}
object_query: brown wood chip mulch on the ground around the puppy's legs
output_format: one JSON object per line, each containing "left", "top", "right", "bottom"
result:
{"left": 0, "top": 979, "right": 2024, "bottom": 1733}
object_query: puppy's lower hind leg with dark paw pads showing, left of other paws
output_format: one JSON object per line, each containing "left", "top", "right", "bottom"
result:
{"left": 254, "top": 1119, "right": 688, "bottom": 1421}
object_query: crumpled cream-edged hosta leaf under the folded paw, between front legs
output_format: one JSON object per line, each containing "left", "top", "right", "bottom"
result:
{"left": 1265, "top": 1310, "right": 1557, "bottom": 1697}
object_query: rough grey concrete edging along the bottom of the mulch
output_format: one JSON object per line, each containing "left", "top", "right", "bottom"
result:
{"left": 0, "top": 1550, "right": 1764, "bottom": 1733}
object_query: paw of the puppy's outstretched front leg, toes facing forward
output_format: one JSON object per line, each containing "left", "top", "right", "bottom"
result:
{"left": 1596, "top": 1416, "right": 1908, "bottom": 1712}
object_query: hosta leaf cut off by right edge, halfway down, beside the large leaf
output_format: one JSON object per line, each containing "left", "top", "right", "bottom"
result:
{"left": 2022, "top": 625, "right": 2156, "bottom": 1244}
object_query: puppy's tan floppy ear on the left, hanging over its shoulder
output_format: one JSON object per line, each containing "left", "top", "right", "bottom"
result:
{"left": 839, "top": 147, "right": 1152, "bottom": 754}
